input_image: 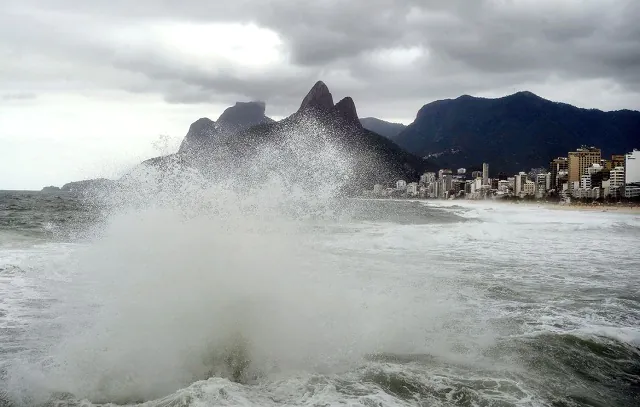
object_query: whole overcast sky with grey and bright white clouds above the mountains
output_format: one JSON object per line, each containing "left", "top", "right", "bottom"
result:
{"left": 0, "top": 0, "right": 640, "bottom": 189}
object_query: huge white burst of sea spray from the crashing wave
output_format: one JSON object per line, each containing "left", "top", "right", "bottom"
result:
{"left": 5, "top": 118, "right": 452, "bottom": 403}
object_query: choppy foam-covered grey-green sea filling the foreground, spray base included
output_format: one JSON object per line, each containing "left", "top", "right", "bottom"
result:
{"left": 0, "top": 192, "right": 640, "bottom": 406}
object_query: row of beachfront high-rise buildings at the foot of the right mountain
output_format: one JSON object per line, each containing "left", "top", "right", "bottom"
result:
{"left": 365, "top": 147, "right": 640, "bottom": 200}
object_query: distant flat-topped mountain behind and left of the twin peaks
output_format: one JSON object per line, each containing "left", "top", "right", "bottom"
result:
{"left": 179, "top": 101, "right": 273, "bottom": 152}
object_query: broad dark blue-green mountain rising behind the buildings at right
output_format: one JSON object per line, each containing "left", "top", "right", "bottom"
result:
{"left": 394, "top": 92, "right": 640, "bottom": 174}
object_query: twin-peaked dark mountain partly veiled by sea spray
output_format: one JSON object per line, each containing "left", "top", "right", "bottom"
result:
{"left": 168, "top": 81, "right": 435, "bottom": 192}
